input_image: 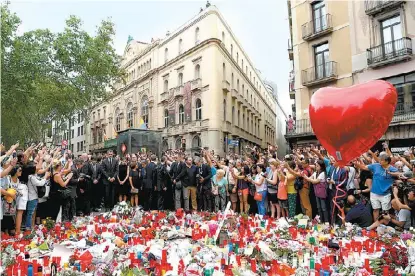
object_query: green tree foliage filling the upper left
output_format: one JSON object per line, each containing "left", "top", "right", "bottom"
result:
{"left": 1, "top": 5, "right": 123, "bottom": 147}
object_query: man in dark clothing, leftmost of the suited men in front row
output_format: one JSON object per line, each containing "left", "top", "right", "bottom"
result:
{"left": 76, "top": 153, "right": 94, "bottom": 216}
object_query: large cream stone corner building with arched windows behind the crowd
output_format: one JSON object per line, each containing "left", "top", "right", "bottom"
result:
{"left": 88, "top": 6, "right": 276, "bottom": 154}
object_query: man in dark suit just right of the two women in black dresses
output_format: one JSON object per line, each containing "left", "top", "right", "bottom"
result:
{"left": 143, "top": 154, "right": 157, "bottom": 211}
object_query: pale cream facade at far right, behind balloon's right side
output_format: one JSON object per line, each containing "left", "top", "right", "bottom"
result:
{"left": 349, "top": 1, "right": 415, "bottom": 152}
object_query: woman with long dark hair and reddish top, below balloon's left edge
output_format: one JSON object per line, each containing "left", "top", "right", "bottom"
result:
{"left": 302, "top": 159, "right": 329, "bottom": 222}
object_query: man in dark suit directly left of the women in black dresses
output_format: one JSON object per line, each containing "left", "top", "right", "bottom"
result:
{"left": 101, "top": 150, "right": 118, "bottom": 209}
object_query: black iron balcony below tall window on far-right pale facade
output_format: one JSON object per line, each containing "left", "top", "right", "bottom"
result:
{"left": 366, "top": 37, "right": 412, "bottom": 68}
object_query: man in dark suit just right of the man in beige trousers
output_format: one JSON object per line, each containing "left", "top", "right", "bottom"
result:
{"left": 195, "top": 157, "right": 212, "bottom": 211}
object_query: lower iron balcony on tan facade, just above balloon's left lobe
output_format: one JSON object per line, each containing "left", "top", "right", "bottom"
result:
{"left": 301, "top": 61, "right": 337, "bottom": 87}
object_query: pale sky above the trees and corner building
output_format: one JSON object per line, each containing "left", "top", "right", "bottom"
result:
{"left": 10, "top": 0, "right": 290, "bottom": 114}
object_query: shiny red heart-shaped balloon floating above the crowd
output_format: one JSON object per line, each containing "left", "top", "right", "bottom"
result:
{"left": 309, "top": 80, "right": 397, "bottom": 166}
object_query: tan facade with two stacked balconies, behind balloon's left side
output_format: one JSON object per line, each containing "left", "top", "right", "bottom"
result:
{"left": 286, "top": 0, "right": 353, "bottom": 147}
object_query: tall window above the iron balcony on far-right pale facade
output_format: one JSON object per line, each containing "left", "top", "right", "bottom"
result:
{"left": 381, "top": 15, "right": 402, "bottom": 55}
